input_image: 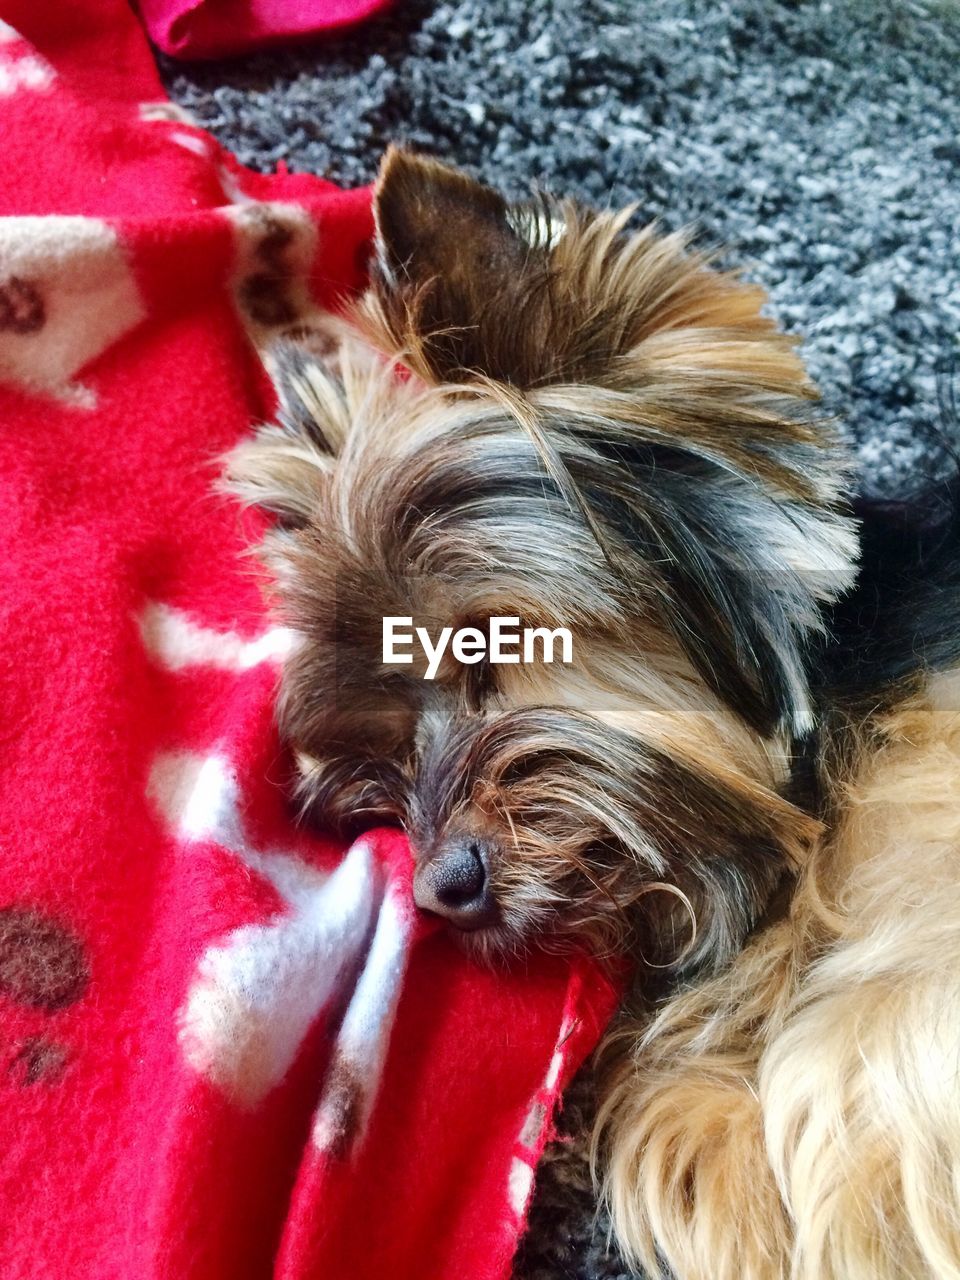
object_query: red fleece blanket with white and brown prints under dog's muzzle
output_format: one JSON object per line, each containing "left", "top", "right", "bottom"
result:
{"left": 0, "top": 0, "right": 613, "bottom": 1280}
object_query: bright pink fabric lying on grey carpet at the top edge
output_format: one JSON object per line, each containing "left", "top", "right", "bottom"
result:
{"left": 140, "top": 0, "right": 389, "bottom": 58}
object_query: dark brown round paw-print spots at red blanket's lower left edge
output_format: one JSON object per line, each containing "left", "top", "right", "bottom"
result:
{"left": 0, "top": 905, "right": 90, "bottom": 1085}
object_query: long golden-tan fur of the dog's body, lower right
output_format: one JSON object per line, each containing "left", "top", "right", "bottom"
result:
{"left": 598, "top": 672, "right": 960, "bottom": 1280}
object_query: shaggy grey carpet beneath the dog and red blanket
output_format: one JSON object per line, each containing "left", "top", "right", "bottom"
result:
{"left": 163, "top": 0, "right": 960, "bottom": 1280}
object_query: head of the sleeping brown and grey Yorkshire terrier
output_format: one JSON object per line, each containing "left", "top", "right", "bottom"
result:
{"left": 230, "top": 151, "right": 855, "bottom": 965}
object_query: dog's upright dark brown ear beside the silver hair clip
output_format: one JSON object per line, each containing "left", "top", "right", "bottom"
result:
{"left": 366, "top": 147, "right": 562, "bottom": 387}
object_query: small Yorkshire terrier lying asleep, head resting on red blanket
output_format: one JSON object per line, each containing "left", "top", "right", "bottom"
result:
{"left": 229, "top": 150, "right": 960, "bottom": 1280}
